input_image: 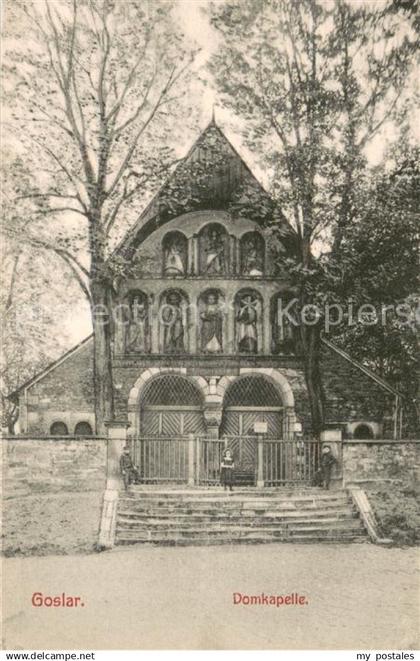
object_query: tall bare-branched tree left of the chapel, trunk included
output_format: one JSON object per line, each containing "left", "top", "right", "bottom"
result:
{"left": 6, "top": 0, "right": 197, "bottom": 431}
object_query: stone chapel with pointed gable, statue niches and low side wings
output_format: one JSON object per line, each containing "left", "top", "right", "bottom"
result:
{"left": 12, "top": 121, "right": 398, "bottom": 458}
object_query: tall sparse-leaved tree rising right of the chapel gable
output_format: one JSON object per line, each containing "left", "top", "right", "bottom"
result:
{"left": 210, "top": 0, "right": 414, "bottom": 433}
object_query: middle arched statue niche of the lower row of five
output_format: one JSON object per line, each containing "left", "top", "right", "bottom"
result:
{"left": 198, "top": 289, "right": 226, "bottom": 354}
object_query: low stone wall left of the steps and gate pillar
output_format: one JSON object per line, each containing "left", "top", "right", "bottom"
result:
{"left": 2, "top": 436, "right": 107, "bottom": 498}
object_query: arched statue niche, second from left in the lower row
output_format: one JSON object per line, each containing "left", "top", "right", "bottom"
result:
{"left": 159, "top": 289, "right": 189, "bottom": 354}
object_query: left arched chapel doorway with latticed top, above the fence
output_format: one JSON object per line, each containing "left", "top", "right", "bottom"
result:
{"left": 140, "top": 374, "right": 205, "bottom": 437}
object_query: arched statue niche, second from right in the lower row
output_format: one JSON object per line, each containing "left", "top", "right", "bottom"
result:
{"left": 235, "top": 288, "right": 263, "bottom": 354}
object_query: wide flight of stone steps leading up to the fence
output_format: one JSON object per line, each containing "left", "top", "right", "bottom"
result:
{"left": 115, "top": 486, "right": 366, "bottom": 546}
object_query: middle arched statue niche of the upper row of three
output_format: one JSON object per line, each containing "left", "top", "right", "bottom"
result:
{"left": 198, "top": 223, "right": 230, "bottom": 278}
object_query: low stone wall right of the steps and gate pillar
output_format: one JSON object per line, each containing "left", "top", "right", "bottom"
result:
{"left": 342, "top": 439, "right": 420, "bottom": 486}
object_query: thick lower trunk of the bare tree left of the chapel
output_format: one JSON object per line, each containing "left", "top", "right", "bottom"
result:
{"left": 91, "top": 281, "right": 114, "bottom": 434}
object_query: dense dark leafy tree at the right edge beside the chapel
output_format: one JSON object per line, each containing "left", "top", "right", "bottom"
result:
{"left": 334, "top": 142, "right": 420, "bottom": 431}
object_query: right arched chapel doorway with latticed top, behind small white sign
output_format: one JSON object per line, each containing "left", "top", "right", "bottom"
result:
{"left": 221, "top": 375, "right": 283, "bottom": 484}
